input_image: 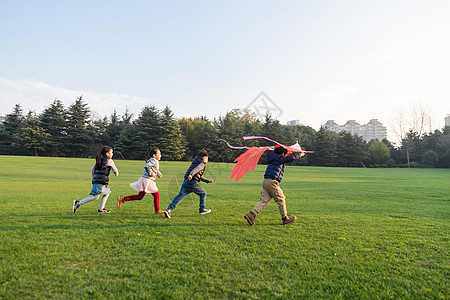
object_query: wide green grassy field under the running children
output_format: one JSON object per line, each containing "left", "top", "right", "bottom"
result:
{"left": 0, "top": 156, "right": 450, "bottom": 299}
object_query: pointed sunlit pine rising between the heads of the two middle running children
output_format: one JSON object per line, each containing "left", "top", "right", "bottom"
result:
{"left": 159, "top": 106, "right": 186, "bottom": 160}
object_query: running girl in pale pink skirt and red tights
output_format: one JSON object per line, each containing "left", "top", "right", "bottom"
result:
{"left": 117, "top": 148, "right": 164, "bottom": 215}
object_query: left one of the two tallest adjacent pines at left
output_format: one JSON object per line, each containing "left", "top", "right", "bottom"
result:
{"left": 40, "top": 99, "right": 67, "bottom": 156}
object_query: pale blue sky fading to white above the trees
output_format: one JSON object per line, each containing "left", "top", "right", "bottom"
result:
{"left": 0, "top": 0, "right": 450, "bottom": 143}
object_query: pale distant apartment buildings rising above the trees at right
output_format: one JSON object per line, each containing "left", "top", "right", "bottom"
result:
{"left": 324, "top": 119, "right": 387, "bottom": 142}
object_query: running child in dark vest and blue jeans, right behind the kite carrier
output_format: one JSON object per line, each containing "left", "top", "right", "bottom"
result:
{"left": 164, "top": 149, "right": 213, "bottom": 218}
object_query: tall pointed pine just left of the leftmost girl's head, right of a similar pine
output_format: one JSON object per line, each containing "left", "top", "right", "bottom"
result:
{"left": 66, "top": 96, "right": 93, "bottom": 157}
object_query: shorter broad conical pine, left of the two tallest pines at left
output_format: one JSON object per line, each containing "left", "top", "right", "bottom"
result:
{"left": 16, "top": 111, "right": 50, "bottom": 156}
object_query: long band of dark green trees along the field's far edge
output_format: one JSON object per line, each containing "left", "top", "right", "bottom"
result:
{"left": 0, "top": 96, "right": 450, "bottom": 168}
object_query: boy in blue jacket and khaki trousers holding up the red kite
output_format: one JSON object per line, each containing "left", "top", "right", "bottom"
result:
{"left": 244, "top": 146, "right": 301, "bottom": 225}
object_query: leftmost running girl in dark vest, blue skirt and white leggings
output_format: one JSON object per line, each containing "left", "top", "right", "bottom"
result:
{"left": 72, "top": 146, "right": 119, "bottom": 213}
